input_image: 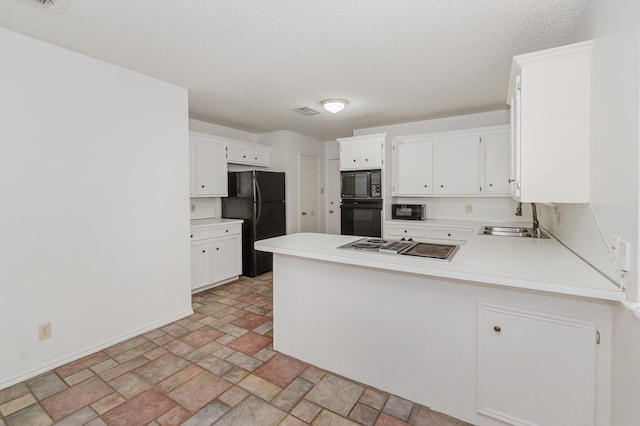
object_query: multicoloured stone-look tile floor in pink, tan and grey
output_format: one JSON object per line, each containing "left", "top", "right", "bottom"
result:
{"left": 0, "top": 274, "right": 466, "bottom": 426}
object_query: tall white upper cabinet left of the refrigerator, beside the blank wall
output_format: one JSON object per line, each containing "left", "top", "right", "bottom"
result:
{"left": 189, "top": 132, "right": 227, "bottom": 197}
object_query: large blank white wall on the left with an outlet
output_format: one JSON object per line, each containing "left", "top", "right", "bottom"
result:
{"left": 0, "top": 29, "right": 191, "bottom": 388}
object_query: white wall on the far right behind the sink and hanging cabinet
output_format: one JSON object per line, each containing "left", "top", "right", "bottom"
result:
{"left": 556, "top": 0, "right": 640, "bottom": 426}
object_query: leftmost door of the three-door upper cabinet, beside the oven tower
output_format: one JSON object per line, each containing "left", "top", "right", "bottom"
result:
{"left": 391, "top": 138, "right": 433, "bottom": 196}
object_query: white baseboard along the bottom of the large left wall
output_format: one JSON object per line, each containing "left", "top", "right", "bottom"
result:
{"left": 0, "top": 309, "right": 193, "bottom": 390}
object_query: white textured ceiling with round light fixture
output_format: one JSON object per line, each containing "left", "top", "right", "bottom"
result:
{"left": 0, "top": 0, "right": 587, "bottom": 140}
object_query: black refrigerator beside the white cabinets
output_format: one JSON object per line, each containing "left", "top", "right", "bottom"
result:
{"left": 222, "top": 170, "right": 287, "bottom": 277}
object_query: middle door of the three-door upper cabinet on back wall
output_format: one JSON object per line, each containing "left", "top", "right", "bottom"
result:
{"left": 434, "top": 134, "right": 480, "bottom": 195}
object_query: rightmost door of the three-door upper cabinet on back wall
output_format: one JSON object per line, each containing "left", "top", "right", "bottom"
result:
{"left": 480, "top": 128, "right": 510, "bottom": 195}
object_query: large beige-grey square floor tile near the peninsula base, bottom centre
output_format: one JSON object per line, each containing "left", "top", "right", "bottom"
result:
{"left": 305, "top": 374, "right": 364, "bottom": 417}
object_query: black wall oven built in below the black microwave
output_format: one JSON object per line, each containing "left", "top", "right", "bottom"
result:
{"left": 340, "top": 199, "right": 382, "bottom": 237}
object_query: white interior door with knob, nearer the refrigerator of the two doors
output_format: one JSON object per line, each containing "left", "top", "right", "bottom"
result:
{"left": 298, "top": 153, "right": 320, "bottom": 232}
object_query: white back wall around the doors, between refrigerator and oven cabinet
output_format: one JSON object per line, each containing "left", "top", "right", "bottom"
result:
{"left": 258, "top": 130, "right": 326, "bottom": 234}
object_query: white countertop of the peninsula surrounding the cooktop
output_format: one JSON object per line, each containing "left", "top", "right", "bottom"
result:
{"left": 255, "top": 226, "right": 626, "bottom": 301}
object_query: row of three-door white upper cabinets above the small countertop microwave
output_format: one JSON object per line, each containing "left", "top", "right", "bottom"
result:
{"left": 391, "top": 125, "right": 509, "bottom": 197}
